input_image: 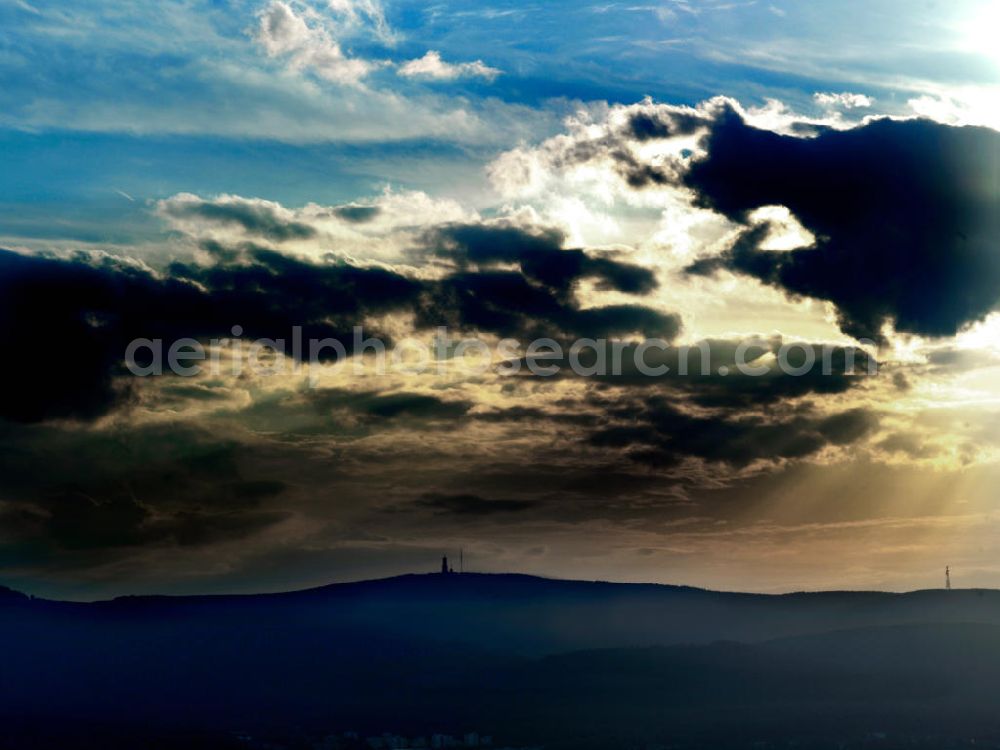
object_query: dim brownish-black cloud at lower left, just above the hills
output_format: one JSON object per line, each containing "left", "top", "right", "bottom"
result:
{"left": 0, "top": 425, "right": 289, "bottom": 559}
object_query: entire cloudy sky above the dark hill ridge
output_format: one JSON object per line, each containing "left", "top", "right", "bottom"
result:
{"left": 0, "top": 0, "right": 1000, "bottom": 599}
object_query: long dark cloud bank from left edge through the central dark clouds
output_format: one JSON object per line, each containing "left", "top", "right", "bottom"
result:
{"left": 0, "top": 217, "right": 680, "bottom": 422}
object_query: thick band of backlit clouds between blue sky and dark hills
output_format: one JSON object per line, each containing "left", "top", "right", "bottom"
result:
{"left": 0, "top": 81, "right": 1000, "bottom": 600}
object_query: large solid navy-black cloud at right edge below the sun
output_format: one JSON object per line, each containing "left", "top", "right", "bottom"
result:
{"left": 684, "top": 109, "right": 1000, "bottom": 339}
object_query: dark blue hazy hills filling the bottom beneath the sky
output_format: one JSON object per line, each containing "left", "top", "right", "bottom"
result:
{"left": 0, "top": 574, "right": 1000, "bottom": 748}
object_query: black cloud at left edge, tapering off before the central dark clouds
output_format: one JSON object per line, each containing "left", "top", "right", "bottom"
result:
{"left": 0, "top": 249, "right": 422, "bottom": 422}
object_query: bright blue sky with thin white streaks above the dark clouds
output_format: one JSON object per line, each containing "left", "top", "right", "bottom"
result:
{"left": 0, "top": 0, "right": 996, "bottom": 250}
